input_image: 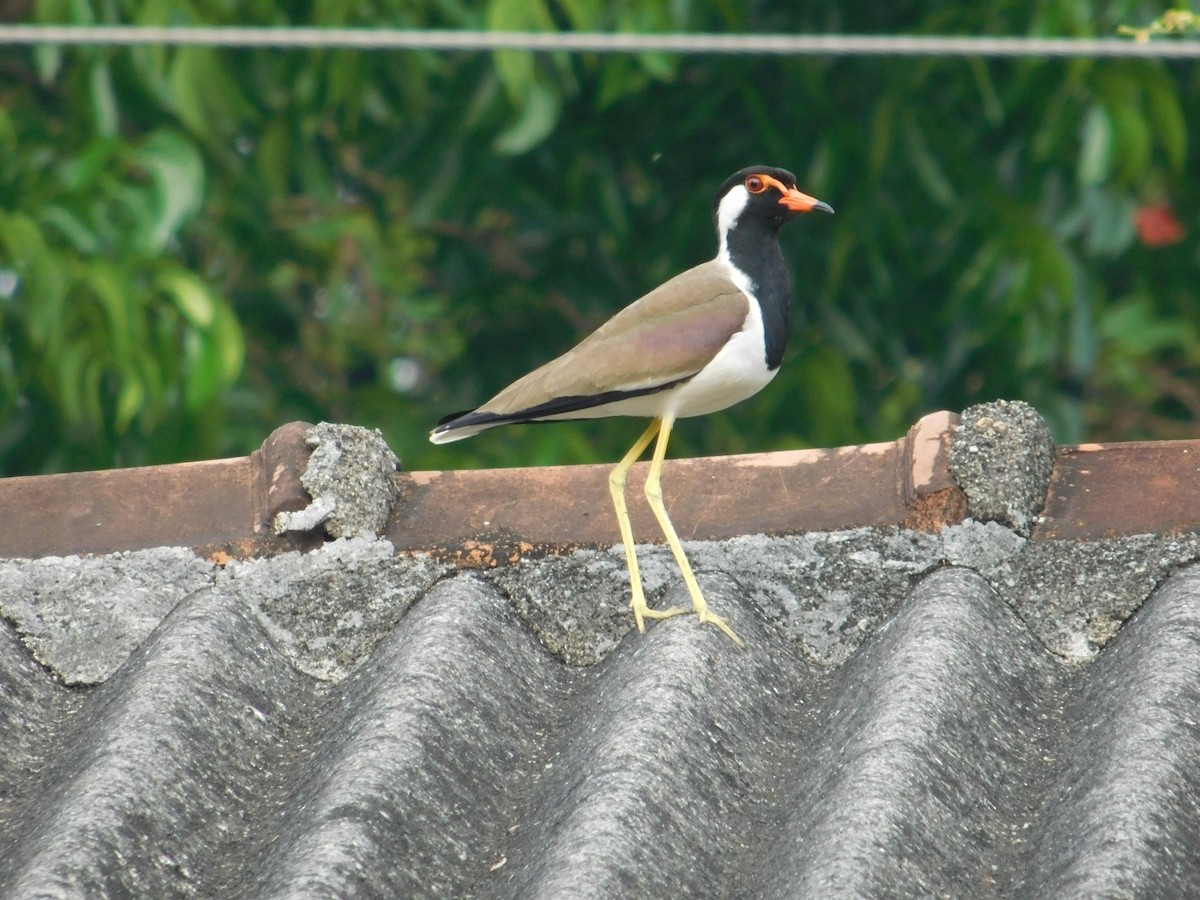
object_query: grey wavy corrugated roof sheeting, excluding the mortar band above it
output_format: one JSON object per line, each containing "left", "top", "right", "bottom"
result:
{"left": 0, "top": 554, "right": 1200, "bottom": 896}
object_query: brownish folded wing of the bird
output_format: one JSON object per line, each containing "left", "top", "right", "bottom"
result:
{"left": 478, "top": 260, "right": 750, "bottom": 414}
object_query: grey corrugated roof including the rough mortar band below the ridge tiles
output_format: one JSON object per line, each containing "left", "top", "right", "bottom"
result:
{"left": 0, "top": 410, "right": 1200, "bottom": 898}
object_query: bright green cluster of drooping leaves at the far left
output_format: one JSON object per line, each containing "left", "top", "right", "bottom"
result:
{"left": 0, "top": 116, "right": 244, "bottom": 468}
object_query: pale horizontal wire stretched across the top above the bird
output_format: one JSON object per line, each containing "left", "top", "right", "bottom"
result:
{"left": 0, "top": 25, "right": 1200, "bottom": 59}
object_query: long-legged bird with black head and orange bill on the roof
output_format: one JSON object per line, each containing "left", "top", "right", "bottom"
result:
{"left": 430, "top": 166, "right": 833, "bottom": 647}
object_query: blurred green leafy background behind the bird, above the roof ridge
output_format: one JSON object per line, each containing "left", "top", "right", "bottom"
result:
{"left": 0, "top": 0, "right": 1200, "bottom": 475}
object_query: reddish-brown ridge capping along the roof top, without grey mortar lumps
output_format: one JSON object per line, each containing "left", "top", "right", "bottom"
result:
{"left": 0, "top": 412, "right": 1200, "bottom": 560}
